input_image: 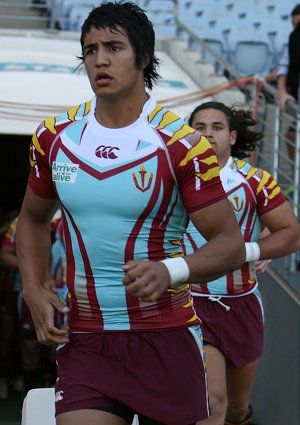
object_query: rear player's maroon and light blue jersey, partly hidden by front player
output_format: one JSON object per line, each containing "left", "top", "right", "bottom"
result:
{"left": 184, "top": 157, "right": 286, "bottom": 296}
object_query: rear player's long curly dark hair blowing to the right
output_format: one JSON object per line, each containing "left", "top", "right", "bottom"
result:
{"left": 189, "top": 101, "right": 263, "bottom": 159}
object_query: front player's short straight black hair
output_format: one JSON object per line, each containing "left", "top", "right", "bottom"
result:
{"left": 80, "top": 1, "right": 159, "bottom": 90}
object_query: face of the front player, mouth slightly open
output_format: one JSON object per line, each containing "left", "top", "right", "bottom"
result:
{"left": 83, "top": 27, "right": 145, "bottom": 99}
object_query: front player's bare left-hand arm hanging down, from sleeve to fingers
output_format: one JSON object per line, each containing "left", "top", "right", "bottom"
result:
{"left": 16, "top": 186, "right": 69, "bottom": 344}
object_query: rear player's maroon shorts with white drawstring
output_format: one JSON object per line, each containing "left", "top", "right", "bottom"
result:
{"left": 194, "top": 291, "right": 264, "bottom": 368}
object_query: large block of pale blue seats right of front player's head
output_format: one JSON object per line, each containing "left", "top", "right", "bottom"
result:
{"left": 178, "top": 0, "right": 298, "bottom": 75}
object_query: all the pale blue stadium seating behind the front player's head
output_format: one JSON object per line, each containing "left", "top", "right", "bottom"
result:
{"left": 47, "top": 0, "right": 297, "bottom": 75}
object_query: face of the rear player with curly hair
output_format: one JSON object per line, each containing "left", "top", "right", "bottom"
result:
{"left": 192, "top": 109, "right": 236, "bottom": 167}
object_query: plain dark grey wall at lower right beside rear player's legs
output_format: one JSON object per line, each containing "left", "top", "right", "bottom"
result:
{"left": 252, "top": 273, "right": 300, "bottom": 425}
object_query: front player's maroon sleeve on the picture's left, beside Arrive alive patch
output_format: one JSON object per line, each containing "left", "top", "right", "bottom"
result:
{"left": 28, "top": 122, "right": 57, "bottom": 199}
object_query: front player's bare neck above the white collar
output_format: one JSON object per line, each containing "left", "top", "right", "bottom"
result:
{"left": 95, "top": 91, "right": 149, "bottom": 128}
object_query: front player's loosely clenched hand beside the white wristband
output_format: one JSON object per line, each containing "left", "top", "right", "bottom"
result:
{"left": 123, "top": 261, "right": 170, "bottom": 302}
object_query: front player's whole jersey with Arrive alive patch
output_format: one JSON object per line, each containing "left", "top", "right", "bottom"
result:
{"left": 29, "top": 98, "right": 226, "bottom": 332}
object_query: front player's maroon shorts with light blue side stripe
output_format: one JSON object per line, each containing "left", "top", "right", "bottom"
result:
{"left": 55, "top": 326, "right": 209, "bottom": 425}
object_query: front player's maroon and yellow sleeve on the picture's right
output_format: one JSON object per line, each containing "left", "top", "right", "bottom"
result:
{"left": 177, "top": 132, "right": 226, "bottom": 213}
